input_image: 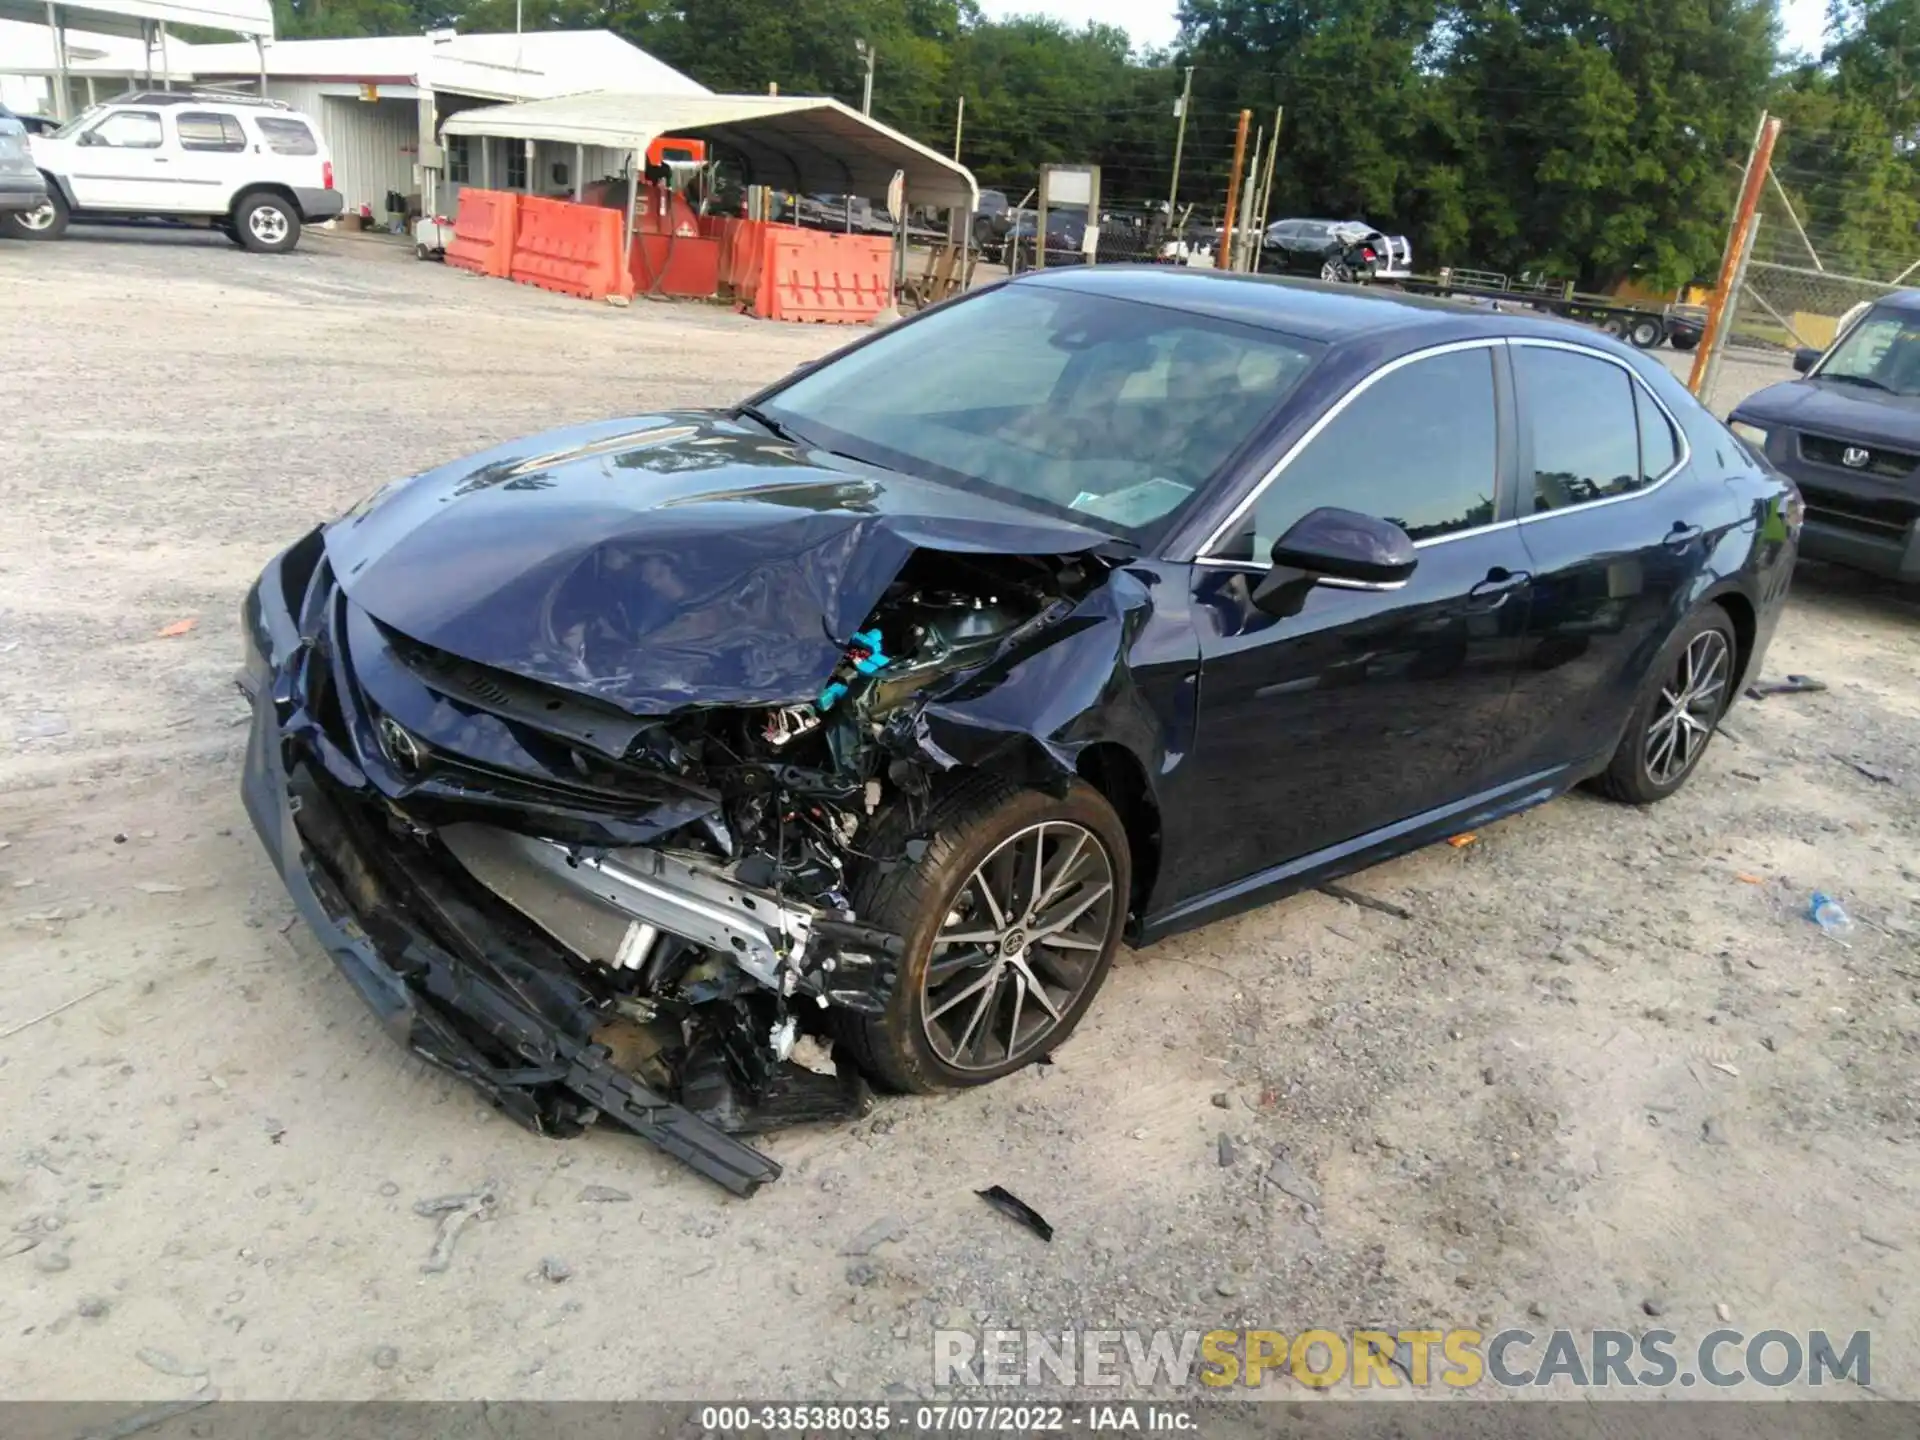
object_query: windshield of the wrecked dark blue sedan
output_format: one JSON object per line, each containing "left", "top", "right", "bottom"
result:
{"left": 760, "top": 284, "right": 1321, "bottom": 540}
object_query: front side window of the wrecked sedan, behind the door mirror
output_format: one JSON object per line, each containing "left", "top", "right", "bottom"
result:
{"left": 1212, "top": 346, "right": 1500, "bottom": 564}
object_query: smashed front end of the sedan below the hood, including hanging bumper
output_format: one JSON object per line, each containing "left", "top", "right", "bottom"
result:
{"left": 242, "top": 485, "right": 1140, "bottom": 1194}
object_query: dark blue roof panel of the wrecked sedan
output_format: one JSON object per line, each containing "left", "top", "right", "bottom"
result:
{"left": 1010, "top": 265, "right": 1582, "bottom": 349}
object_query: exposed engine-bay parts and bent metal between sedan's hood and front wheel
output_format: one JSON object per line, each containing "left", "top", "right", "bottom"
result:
{"left": 401, "top": 551, "right": 1100, "bottom": 1133}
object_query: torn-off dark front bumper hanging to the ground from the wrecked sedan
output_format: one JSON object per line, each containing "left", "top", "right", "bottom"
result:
{"left": 240, "top": 532, "right": 780, "bottom": 1194}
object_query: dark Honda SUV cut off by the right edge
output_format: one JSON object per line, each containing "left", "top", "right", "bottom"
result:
{"left": 1728, "top": 290, "right": 1920, "bottom": 584}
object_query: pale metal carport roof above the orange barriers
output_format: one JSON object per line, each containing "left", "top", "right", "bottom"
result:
{"left": 445, "top": 90, "right": 979, "bottom": 209}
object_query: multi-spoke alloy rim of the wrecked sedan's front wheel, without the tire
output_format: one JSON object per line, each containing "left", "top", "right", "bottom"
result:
{"left": 920, "top": 820, "right": 1119, "bottom": 1071}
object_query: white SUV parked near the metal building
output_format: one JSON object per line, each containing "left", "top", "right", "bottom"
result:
{"left": 0, "top": 90, "right": 342, "bottom": 252}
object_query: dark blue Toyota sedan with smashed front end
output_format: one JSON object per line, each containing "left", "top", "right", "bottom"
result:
{"left": 242, "top": 267, "right": 1801, "bottom": 1194}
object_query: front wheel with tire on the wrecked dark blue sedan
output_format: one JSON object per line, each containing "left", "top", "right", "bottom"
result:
{"left": 845, "top": 776, "right": 1133, "bottom": 1094}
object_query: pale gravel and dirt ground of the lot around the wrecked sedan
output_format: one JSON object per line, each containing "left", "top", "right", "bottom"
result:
{"left": 0, "top": 230, "right": 1920, "bottom": 1400}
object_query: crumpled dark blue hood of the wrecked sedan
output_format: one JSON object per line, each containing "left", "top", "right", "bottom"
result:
{"left": 326, "top": 411, "right": 1110, "bottom": 714}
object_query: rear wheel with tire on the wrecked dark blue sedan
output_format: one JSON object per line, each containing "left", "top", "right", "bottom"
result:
{"left": 1594, "top": 605, "right": 1740, "bottom": 804}
